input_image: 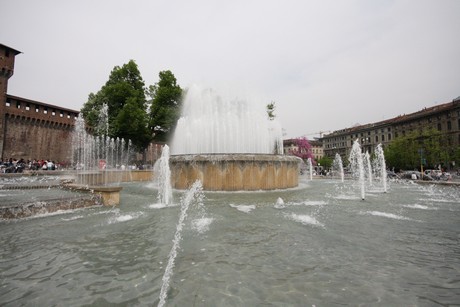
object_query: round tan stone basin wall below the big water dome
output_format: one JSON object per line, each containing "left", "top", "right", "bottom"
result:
{"left": 169, "top": 154, "right": 302, "bottom": 191}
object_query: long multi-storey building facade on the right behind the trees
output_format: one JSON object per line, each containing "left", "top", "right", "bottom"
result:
{"left": 321, "top": 97, "right": 460, "bottom": 161}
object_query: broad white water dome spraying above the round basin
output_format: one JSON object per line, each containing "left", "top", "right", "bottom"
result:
{"left": 171, "top": 86, "right": 283, "bottom": 155}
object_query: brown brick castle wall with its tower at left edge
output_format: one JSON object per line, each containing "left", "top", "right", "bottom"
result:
{"left": 0, "top": 44, "right": 79, "bottom": 163}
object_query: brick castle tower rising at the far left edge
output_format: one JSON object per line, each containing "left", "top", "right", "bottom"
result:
{"left": 0, "top": 44, "right": 21, "bottom": 160}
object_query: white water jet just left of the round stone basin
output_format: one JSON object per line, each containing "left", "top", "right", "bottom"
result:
{"left": 153, "top": 145, "right": 172, "bottom": 205}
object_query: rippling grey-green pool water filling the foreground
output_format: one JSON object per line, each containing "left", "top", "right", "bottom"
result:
{"left": 0, "top": 180, "right": 460, "bottom": 306}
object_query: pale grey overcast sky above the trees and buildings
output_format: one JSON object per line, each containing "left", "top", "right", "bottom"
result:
{"left": 0, "top": 0, "right": 460, "bottom": 138}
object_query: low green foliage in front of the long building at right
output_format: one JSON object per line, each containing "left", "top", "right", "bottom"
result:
{"left": 385, "top": 128, "right": 456, "bottom": 169}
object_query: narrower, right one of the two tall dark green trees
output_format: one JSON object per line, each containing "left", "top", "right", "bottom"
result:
{"left": 147, "top": 70, "right": 183, "bottom": 142}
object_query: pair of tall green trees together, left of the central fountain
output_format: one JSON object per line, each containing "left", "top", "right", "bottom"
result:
{"left": 81, "top": 60, "right": 183, "bottom": 151}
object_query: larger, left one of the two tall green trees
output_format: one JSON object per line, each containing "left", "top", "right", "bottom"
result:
{"left": 81, "top": 60, "right": 151, "bottom": 150}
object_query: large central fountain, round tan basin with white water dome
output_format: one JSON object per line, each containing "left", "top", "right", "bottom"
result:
{"left": 170, "top": 86, "right": 301, "bottom": 191}
